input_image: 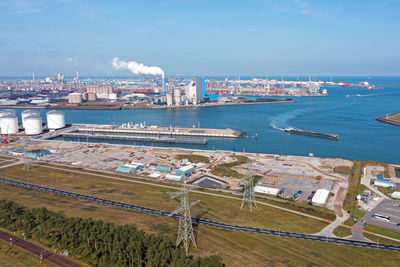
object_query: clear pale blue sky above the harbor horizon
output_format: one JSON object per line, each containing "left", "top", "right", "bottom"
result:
{"left": 0, "top": 0, "right": 400, "bottom": 76}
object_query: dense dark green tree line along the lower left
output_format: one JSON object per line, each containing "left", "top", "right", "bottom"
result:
{"left": 0, "top": 200, "right": 223, "bottom": 267}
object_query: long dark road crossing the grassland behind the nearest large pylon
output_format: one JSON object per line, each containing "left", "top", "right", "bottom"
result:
{"left": 0, "top": 178, "right": 400, "bottom": 252}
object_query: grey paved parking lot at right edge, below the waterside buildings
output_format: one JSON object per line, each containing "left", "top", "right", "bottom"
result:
{"left": 362, "top": 199, "right": 400, "bottom": 230}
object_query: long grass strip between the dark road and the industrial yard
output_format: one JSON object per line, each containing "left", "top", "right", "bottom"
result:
{"left": 0, "top": 165, "right": 326, "bottom": 233}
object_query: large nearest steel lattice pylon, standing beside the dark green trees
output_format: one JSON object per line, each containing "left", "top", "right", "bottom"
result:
{"left": 168, "top": 184, "right": 200, "bottom": 254}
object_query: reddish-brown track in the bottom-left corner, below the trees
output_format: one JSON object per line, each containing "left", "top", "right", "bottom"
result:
{"left": 0, "top": 231, "right": 80, "bottom": 267}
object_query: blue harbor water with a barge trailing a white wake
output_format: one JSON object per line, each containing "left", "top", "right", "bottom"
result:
{"left": 5, "top": 77, "right": 400, "bottom": 164}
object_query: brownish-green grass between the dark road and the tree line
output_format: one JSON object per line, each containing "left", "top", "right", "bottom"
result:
{"left": 0, "top": 184, "right": 400, "bottom": 266}
